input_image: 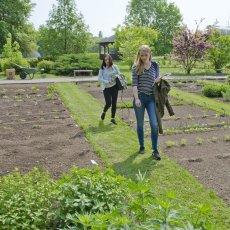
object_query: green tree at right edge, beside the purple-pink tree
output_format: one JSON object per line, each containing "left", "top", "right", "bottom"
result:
{"left": 207, "top": 30, "right": 230, "bottom": 73}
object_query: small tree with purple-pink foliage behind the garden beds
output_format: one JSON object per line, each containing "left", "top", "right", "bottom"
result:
{"left": 172, "top": 26, "right": 212, "bottom": 74}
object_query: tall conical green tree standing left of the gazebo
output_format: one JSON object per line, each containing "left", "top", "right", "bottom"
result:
{"left": 39, "top": 0, "right": 90, "bottom": 56}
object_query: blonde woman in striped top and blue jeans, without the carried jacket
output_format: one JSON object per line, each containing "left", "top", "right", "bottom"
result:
{"left": 132, "top": 45, "right": 161, "bottom": 160}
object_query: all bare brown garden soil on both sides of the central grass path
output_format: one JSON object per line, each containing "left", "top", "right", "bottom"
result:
{"left": 0, "top": 80, "right": 230, "bottom": 204}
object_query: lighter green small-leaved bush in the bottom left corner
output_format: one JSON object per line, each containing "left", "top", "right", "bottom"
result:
{"left": 0, "top": 168, "right": 56, "bottom": 230}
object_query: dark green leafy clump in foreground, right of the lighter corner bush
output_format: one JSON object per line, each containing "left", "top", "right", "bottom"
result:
{"left": 49, "top": 167, "right": 127, "bottom": 227}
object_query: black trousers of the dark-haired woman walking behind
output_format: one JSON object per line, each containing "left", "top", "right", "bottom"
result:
{"left": 103, "top": 85, "right": 118, "bottom": 118}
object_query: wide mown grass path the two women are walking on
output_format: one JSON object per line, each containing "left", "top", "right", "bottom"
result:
{"left": 55, "top": 83, "right": 230, "bottom": 229}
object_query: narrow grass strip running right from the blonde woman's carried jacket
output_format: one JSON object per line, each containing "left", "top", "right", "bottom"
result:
{"left": 169, "top": 88, "right": 230, "bottom": 116}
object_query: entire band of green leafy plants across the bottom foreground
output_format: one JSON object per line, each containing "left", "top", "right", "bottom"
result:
{"left": 0, "top": 167, "right": 221, "bottom": 229}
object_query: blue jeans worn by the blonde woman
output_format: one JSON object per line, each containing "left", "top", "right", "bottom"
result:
{"left": 133, "top": 93, "right": 158, "bottom": 150}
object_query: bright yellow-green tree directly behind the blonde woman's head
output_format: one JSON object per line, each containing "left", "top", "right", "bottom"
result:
{"left": 115, "top": 26, "right": 158, "bottom": 68}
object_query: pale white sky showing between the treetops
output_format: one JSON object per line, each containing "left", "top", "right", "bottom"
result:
{"left": 30, "top": 0, "right": 230, "bottom": 37}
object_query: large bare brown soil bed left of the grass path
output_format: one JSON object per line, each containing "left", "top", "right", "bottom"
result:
{"left": 0, "top": 84, "right": 103, "bottom": 178}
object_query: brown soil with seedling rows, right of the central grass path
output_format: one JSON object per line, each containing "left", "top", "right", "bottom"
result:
{"left": 81, "top": 83, "right": 230, "bottom": 204}
